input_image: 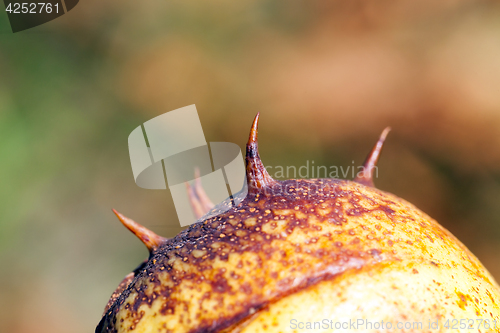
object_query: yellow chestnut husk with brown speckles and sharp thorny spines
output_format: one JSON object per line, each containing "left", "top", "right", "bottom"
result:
{"left": 96, "top": 115, "right": 500, "bottom": 333}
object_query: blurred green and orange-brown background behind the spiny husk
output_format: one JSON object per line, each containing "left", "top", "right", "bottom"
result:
{"left": 0, "top": 0, "right": 500, "bottom": 333}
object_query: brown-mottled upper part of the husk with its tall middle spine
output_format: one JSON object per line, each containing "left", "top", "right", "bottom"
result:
{"left": 96, "top": 115, "right": 460, "bottom": 333}
